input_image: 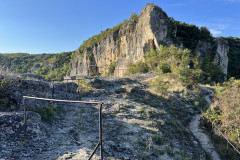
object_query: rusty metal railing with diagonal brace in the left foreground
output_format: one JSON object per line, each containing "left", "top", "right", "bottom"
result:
{"left": 23, "top": 96, "right": 104, "bottom": 160}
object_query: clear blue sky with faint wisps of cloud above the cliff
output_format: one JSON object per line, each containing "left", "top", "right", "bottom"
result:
{"left": 0, "top": 0, "right": 240, "bottom": 53}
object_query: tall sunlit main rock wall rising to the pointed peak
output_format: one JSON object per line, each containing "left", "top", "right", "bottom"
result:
{"left": 67, "top": 4, "right": 173, "bottom": 76}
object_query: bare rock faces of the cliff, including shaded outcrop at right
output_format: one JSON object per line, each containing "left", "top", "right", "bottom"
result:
{"left": 69, "top": 4, "right": 229, "bottom": 76}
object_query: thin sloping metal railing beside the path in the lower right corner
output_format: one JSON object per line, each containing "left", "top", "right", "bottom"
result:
{"left": 201, "top": 110, "right": 240, "bottom": 160}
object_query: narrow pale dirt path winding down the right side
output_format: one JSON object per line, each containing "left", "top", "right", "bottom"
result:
{"left": 189, "top": 86, "right": 221, "bottom": 160}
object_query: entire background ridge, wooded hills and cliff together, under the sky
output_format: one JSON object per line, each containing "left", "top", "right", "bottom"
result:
{"left": 0, "top": 4, "right": 240, "bottom": 80}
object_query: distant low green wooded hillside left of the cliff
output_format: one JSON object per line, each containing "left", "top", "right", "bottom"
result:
{"left": 0, "top": 52, "right": 72, "bottom": 80}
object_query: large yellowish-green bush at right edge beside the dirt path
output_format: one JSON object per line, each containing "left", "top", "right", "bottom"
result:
{"left": 206, "top": 78, "right": 240, "bottom": 149}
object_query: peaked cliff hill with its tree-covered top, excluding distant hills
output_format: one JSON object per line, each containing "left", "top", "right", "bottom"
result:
{"left": 69, "top": 4, "right": 229, "bottom": 81}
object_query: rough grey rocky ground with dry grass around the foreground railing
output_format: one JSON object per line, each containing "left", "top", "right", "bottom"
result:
{"left": 0, "top": 73, "right": 207, "bottom": 160}
